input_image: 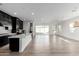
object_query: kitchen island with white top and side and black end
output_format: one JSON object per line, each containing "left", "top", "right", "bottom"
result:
{"left": 9, "top": 34, "right": 32, "bottom": 52}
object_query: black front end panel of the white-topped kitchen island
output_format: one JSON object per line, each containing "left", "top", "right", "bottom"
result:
{"left": 9, "top": 38, "right": 19, "bottom": 52}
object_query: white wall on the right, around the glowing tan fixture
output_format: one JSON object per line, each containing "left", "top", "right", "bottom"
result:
{"left": 57, "top": 17, "right": 79, "bottom": 40}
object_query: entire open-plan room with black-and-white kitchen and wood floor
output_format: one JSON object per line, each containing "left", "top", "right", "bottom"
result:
{"left": 0, "top": 3, "right": 79, "bottom": 56}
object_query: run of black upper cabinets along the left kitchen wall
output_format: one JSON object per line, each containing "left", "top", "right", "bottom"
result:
{"left": 0, "top": 10, "right": 23, "bottom": 33}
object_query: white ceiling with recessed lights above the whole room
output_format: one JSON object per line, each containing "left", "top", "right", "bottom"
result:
{"left": 0, "top": 3, "right": 79, "bottom": 23}
